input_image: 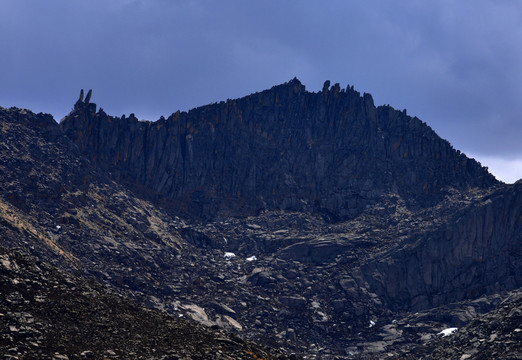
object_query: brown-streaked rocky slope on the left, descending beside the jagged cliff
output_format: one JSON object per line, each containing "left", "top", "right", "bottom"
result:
{"left": 0, "top": 108, "right": 184, "bottom": 288}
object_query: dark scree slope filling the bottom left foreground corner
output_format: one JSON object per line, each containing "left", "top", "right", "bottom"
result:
{"left": 0, "top": 248, "right": 297, "bottom": 360}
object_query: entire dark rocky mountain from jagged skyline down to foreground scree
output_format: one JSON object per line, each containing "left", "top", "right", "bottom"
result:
{"left": 0, "top": 79, "right": 522, "bottom": 359}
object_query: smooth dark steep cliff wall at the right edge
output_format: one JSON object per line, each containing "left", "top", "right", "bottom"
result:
{"left": 362, "top": 181, "right": 522, "bottom": 311}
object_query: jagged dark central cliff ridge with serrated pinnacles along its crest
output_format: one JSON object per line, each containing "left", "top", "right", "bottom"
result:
{"left": 61, "top": 79, "right": 497, "bottom": 220}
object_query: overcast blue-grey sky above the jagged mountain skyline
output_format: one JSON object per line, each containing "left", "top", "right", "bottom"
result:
{"left": 0, "top": 0, "right": 522, "bottom": 182}
